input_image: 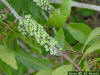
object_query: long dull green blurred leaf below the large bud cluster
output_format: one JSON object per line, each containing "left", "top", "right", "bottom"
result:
{"left": 14, "top": 46, "right": 50, "bottom": 70}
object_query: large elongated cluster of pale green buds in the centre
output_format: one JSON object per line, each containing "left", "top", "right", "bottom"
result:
{"left": 18, "top": 15, "right": 61, "bottom": 55}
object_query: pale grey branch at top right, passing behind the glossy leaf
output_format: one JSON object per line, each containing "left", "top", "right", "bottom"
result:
{"left": 49, "top": 0, "right": 100, "bottom": 12}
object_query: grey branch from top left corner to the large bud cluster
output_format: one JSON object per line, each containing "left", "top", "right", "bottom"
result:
{"left": 0, "top": 0, "right": 21, "bottom": 19}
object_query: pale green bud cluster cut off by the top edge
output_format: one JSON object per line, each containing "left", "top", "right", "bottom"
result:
{"left": 33, "top": 0, "right": 54, "bottom": 11}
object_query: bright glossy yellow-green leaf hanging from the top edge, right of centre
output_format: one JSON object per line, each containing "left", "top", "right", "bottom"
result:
{"left": 47, "top": 0, "right": 72, "bottom": 27}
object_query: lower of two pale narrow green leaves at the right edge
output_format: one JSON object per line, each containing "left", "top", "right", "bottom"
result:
{"left": 84, "top": 39, "right": 100, "bottom": 55}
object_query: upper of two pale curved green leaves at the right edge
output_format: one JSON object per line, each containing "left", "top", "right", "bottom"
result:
{"left": 85, "top": 27, "right": 100, "bottom": 46}
